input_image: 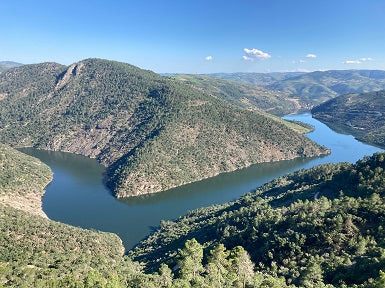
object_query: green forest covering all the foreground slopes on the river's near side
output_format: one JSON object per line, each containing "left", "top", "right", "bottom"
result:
{"left": 0, "top": 145, "right": 385, "bottom": 288}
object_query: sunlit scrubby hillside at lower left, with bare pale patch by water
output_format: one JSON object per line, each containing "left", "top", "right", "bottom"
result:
{"left": 0, "top": 144, "right": 135, "bottom": 287}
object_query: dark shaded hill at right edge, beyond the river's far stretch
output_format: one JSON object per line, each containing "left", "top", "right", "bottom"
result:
{"left": 312, "top": 90, "right": 385, "bottom": 148}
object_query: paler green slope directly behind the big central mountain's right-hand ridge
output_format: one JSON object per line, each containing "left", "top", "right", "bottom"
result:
{"left": 172, "top": 74, "right": 301, "bottom": 116}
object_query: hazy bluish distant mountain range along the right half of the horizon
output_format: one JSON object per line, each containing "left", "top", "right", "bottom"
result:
{"left": 210, "top": 70, "right": 385, "bottom": 109}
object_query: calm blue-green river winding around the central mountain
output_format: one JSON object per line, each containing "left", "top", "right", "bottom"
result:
{"left": 22, "top": 114, "right": 382, "bottom": 249}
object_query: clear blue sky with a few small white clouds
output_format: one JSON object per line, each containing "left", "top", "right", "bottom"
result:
{"left": 0, "top": 0, "right": 385, "bottom": 73}
